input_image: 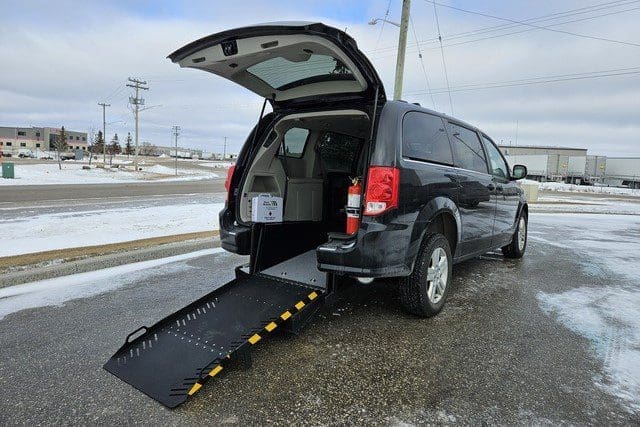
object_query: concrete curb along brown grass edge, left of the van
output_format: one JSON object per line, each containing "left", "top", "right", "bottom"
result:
{"left": 0, "top": 238, "right": 220, "bottom": 288}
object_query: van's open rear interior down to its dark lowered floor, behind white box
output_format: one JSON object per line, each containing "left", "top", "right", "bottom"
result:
{"left": 237, "top": 110, "right": 371, "bottom": 274}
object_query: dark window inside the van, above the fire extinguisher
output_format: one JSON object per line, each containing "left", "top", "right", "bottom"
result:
{"left": 318, "top": 132, "right": 363, "bottom": 172}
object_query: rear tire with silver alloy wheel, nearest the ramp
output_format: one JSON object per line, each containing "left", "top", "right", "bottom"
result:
{"left": 399, "top": 234, "right": 453, "bottom": 317}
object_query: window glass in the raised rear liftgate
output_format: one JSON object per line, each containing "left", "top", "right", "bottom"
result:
{"left": 247, "top": 54, "right": 355, "bottom": 90}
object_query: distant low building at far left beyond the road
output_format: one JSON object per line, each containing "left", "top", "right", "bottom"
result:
{"left": 0, "top": 126, "right": 87, "bottom": 154}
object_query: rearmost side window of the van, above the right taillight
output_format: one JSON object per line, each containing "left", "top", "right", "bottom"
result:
{"left": 402, "top": 111, "right": 453, "bottom": 165}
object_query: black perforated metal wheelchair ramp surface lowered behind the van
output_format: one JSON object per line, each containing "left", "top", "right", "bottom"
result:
{"left": 104, "top": 275, "right": 311, "bottom": 408}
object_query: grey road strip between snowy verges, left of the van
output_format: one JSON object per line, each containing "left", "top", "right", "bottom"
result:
{"left": 0, "top": 179, "right": 224, "bottom": 203}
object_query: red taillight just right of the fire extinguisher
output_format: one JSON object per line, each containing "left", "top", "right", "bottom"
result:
{"left": 364, "top": 166, "right": 400, "bottom": 216}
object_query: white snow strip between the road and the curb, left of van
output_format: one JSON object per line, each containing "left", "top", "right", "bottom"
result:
{"left": 0, "top": 202, "right": 224, "bottom": 256}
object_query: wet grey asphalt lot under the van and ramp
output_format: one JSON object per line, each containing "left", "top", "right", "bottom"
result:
{"left": 0, "top": 215, "right": 640, "bottom": 425}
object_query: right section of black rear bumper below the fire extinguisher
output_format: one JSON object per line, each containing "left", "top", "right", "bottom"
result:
{"left": 316, "top": 222, "right": 412, "bottom": 277}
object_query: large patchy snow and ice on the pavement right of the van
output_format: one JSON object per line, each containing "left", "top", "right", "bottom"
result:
{"left": 530, "top": 214, "right": 640, "bottom": 412}
